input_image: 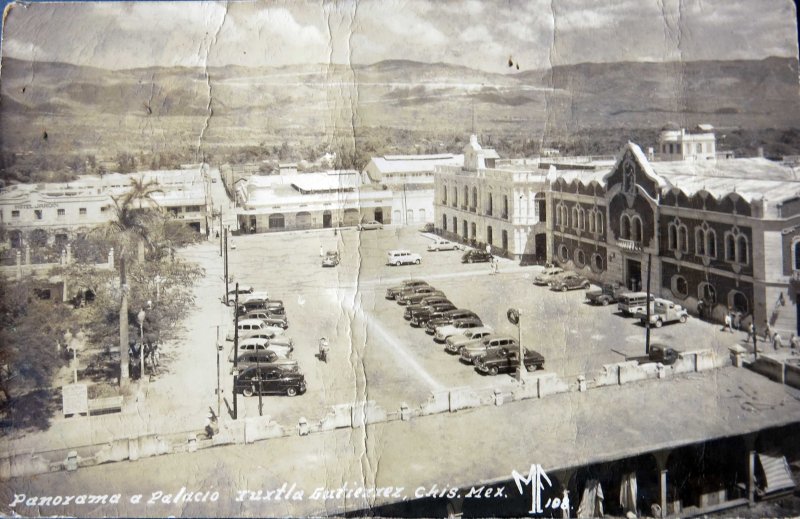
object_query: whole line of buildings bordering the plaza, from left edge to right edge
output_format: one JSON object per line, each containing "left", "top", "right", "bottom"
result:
{"left": 0, "top": 125, "right": 800, "bottom": 333}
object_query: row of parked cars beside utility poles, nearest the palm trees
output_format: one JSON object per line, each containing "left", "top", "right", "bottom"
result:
{"left": 225, "top": 287, "right": 306, "bottom": 396}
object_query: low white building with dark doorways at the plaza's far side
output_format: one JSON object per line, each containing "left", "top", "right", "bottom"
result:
{"left": 236, "top": 171, "right": 392, "bottom": 233}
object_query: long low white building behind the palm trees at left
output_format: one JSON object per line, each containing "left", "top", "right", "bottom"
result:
{"left": 0, "top": 166, "right": 208, "bottom": 248}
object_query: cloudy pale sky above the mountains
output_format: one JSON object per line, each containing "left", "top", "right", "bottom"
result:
{"left": 2, "top": 0, "right": 798, "bottom": 72}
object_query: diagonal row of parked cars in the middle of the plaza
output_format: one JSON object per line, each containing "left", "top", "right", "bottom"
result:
{"left": 386, "top": 280, "right": 544, "bottom": 375}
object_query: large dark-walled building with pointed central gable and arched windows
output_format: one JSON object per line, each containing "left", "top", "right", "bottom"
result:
{"left": 547, "top": 131, "right": 800, "bottom": 338}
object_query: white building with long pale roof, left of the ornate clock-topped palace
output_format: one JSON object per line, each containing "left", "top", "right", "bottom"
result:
{"left": 364, "top": 153, "right": 464, "bottom": 225}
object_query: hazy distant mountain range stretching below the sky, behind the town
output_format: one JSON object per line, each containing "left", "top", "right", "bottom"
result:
{"left": 0, "top": 58, "right": 800, "bottom": 155}
